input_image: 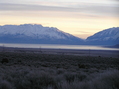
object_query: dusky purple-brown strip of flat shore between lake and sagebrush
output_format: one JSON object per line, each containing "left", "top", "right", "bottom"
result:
{"left": 0, "top": 47, "right": 119, "bottom": 58}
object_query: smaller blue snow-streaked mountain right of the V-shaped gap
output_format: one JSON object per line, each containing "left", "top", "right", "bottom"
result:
{"left": 86, "top": 27, "right": 119, "bottom": 45}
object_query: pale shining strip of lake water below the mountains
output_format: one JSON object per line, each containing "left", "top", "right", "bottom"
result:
{"left": 0, "top": 43, "right": 119, "bottom": 51}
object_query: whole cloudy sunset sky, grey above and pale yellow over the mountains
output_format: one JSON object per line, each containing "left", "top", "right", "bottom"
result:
{"left": 0, "top": 0, "right": 119, "bottom": 39}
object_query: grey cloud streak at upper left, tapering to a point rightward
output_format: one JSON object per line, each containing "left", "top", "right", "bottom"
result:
{"left": 0, "top": 3, "right": 75, "bottom": 11}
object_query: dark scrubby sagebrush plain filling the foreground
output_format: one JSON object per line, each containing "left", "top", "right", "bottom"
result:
{"left": 0, "top": 52, "right": 119, "bottom": 89}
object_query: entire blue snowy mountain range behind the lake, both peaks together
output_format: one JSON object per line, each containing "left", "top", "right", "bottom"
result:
{"left": 0, "top": 24, "right": 119, "bottom": 45}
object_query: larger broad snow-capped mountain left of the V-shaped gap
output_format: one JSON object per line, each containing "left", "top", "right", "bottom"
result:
{"left": 0, "top": 24, "right": 83, "bottom": 44}
